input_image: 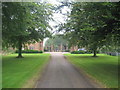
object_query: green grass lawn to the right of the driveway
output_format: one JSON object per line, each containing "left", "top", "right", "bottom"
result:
{"left": 65, "top": 54, "right": 118, "bottom": 88}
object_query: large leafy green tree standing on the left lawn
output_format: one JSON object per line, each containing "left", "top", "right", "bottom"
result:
{"left": 2, "top": 2, "right": 52, "bottom": 58}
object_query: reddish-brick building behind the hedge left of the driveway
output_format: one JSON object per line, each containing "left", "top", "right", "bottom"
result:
{"left": 27, "top": 41, "right": 44, "bottom": 51}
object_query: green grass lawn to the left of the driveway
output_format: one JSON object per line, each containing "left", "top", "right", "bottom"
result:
{"left": 2, "top": 54, "right": 50, "bottom": 88}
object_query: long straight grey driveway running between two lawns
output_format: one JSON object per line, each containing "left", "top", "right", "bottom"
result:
{"left": 36, "top": 52, "right": 99, "bottom": 88}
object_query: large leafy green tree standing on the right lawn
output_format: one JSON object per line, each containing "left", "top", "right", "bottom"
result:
{"left": 61, "top": 2, "right": 120, "bottom": 57}
